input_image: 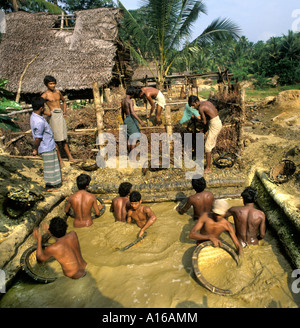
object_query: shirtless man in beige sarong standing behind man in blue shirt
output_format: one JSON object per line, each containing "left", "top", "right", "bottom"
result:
{"left": 42, "top": 75, "right": 74, "bottom": 167}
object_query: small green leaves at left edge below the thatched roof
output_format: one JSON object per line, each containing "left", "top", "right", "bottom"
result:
{"left": 0, "top": 79, "right": 22, "bottom": 131}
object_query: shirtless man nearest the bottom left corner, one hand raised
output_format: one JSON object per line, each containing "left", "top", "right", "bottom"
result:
{"left": 33, "top": 217, "right": 87, "bottom": 279}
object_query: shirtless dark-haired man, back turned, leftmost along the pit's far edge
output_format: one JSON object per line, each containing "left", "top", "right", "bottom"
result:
{"left": 65, "top": 174, "right": 103, "bottom": 228}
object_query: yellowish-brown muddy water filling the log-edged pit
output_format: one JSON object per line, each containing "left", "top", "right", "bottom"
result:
{"left": 0, "top": 200, "right": 300, "bottom": 308}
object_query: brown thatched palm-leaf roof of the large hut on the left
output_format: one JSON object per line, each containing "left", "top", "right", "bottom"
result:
{"left": 0, "top": 8, "right": 121, "bottom": 93}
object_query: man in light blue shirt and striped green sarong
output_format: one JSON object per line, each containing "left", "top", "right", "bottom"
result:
{"left": 30, "top": 97, "right": 62, "bottom": 191}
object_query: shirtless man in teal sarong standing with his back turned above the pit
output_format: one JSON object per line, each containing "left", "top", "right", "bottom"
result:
{"left": 121, "top": 87, "right": 146, "bottom": 158}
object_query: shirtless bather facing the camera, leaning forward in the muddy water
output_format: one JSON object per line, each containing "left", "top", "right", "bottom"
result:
{"left": 127, "top": 191, "right": 156, "bottom": 237}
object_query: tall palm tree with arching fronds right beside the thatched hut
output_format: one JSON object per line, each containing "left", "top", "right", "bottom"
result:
{"left": 118, "top": 0, "right": 240, "bottom": 86}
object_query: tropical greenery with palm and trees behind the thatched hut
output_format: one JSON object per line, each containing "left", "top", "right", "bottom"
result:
{"left": 0, "top": 0, "right": 300, "bottom": 88}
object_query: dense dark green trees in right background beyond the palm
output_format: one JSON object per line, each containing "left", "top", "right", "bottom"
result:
{"left": 174, "top": 31, "right": 300, "bottom": 89}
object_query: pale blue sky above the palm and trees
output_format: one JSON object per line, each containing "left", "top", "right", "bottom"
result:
{"left": 121, "top": 0, "right": 300, "bottom": 42}
